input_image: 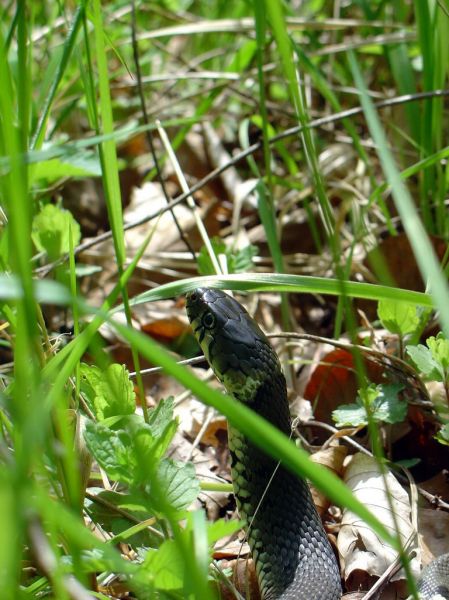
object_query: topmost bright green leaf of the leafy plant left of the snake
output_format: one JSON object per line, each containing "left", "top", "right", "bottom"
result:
{"left": 81, "top": 364, "right": 136, "bottom": 421}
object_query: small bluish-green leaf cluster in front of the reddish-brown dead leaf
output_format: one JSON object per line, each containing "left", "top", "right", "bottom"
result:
{"left": 332, "top": 383, "right": 407, "bottom": 427}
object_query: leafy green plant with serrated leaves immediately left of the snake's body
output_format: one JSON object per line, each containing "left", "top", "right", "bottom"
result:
{"left": 83, "top": 382, "right": 218, "bottom": 597}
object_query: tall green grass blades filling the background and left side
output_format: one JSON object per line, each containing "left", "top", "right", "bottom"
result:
{"left": 0, "top": 0, "right": 449, "bottom": 600}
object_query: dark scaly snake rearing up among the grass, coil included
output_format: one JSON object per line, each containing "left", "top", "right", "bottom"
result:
{"left": 186, "top": 287, "right": 449, "bottom": 600}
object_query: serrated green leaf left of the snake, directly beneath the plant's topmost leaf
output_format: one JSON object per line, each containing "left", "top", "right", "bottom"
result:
{"left": 84, "top": 421, "right": 137, "bottom": 484}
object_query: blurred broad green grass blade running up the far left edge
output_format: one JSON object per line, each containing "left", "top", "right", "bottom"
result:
{"left": 0, "top": 19, "right": 40, "bottom": 600}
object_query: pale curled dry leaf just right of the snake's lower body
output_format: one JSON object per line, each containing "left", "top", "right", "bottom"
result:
{"left": 337, "top": 453, "right": 420, "bottom": 587}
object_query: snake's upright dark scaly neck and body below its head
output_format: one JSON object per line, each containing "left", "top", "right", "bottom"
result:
{"left": 228, "top": 372, "right": 341, "bottom": 600}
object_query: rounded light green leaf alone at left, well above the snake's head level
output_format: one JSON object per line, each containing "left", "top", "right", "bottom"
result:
{"left": 31, "top": 204, "right": 81, "bottom": 260}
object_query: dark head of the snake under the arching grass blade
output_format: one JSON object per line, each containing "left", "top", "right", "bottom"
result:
{"left": 186, "top": 288, "right": 281, "bottom": 403}
